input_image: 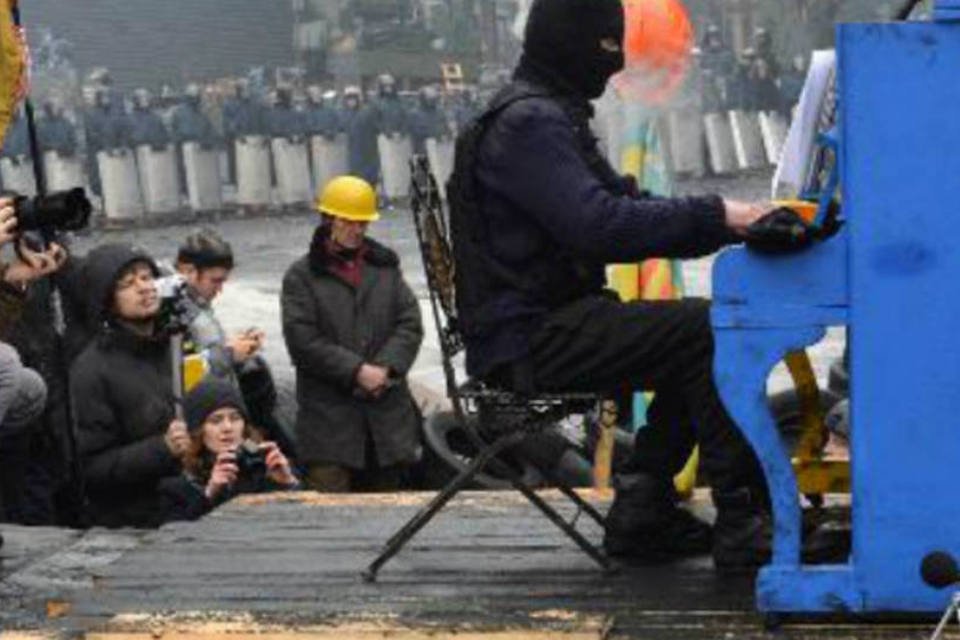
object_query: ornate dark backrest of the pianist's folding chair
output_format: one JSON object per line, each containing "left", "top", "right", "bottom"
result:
{"left": 410, "top": 155, "right": 464, "bottom": 399}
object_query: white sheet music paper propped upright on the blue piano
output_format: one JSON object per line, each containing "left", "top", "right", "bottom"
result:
{"left": 771, "top": 49, "right": 837, "bottom": 200}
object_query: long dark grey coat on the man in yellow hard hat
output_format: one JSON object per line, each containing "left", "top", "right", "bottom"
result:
{"left": 280, "top": 227, "right": 423, "bottom": 469}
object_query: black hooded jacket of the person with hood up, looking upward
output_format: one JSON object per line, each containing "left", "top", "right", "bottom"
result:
{"left": 70, "top": 245, "right": 180, "bottom": 527}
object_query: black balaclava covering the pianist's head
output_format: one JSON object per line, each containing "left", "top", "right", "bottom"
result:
{"left": 520, "top": 0, "right": 624, "bottom": 100}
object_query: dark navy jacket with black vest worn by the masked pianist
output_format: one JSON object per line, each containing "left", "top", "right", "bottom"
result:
{"left": 450, "top": 63, "right": 734, "bottom": 376}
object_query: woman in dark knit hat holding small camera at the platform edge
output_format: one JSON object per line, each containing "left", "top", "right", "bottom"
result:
{"left": 159, "top": 376, "right": 300, "bottom": 522}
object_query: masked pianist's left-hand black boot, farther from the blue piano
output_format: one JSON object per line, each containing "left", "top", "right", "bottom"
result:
{"left": 603, "top": 475, "right": 712, "bottom": 562}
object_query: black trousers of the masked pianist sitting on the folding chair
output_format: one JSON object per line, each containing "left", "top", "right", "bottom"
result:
{"left": 530, "top": 296, "right": 763, "bottom": 490}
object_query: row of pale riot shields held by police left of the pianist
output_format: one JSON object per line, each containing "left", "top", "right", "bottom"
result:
{"left": 0, "top": 129, "right": 453, "bottom": 224}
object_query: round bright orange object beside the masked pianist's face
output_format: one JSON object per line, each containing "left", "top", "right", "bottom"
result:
{"left": 614, "top": 0, "right": 694, "bottom": 106}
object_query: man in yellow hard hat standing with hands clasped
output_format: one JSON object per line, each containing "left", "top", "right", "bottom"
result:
{"left": 280, "top": 176, "right": 423, "bottom": 491}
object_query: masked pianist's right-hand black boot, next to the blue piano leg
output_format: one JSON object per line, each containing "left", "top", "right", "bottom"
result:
{"left": 713, "top": 487, "right": 773, "bottom": 571}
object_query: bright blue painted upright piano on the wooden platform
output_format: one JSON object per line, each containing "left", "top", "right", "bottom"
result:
{"left": 713, "top": 0, "right": 960, "bottom": 613}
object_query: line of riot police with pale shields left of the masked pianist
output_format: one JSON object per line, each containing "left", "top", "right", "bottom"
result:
{"left": 0, "top": 74, "right": 474, "bottom": 225}
